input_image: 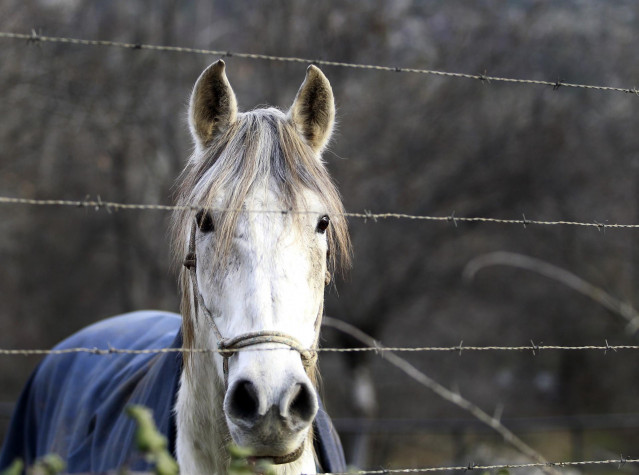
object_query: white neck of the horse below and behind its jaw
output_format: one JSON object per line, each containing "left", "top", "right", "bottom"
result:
{"left": 175, "top": 332, "right": 315, "bottom": 475}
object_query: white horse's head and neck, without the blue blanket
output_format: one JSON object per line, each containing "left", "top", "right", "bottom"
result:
{"left": 174, "top": 61, "right": 348, "bottom": 474}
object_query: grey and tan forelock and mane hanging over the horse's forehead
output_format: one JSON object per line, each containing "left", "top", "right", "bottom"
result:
{"left": 172, "top": 108, "right": 351, "bottom": 372}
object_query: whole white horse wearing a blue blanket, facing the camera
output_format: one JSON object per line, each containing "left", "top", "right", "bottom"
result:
{"left": 0, "top": 60, "right": 350, "bottom": 475}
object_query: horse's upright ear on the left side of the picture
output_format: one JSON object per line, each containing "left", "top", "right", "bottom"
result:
{"left": 189, "top": 59, "right": 237, "bottom": 146}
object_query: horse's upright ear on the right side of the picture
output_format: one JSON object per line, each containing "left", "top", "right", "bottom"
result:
{"left": 288, "top": 65, "right": 335, "bottom": 152}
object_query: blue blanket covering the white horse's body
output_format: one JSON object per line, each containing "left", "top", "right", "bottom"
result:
{"left": 0, "top": 311, "right": 346, "bottom": 473}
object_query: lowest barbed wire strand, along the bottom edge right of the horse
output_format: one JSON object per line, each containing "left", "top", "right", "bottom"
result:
{"left": 322, "top": 457, "right": 639, "bottom": 475}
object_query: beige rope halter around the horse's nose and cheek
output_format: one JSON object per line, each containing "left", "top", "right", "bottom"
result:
{"left": 184, "top": 222, "right": 320, "bottom": 388}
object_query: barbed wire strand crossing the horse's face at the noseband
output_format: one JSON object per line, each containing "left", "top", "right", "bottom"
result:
{"left": 0, "top": 341, "right": 639, "bottom": 356}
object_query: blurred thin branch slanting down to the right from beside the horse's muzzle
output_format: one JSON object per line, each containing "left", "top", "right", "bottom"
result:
{"left": 322, "top": 316, "right": 558, "bottom": 475}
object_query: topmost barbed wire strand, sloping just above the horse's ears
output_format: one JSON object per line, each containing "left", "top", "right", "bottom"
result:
{"left": 0, "top": 30, "right": 639, "bottom": 95}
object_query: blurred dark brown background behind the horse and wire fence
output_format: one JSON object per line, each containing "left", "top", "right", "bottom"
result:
{"left": 0, "top": 0, "right": 639, "bottom": 473}
